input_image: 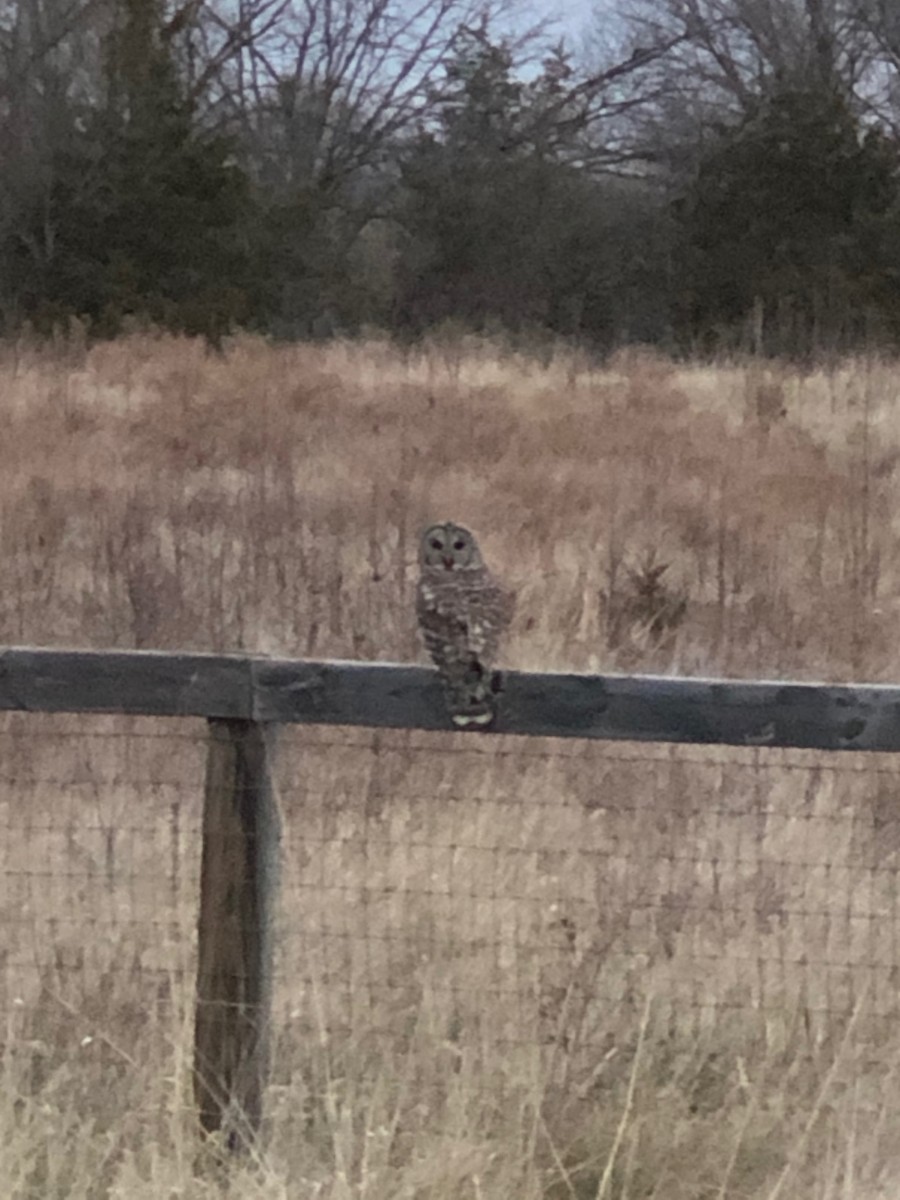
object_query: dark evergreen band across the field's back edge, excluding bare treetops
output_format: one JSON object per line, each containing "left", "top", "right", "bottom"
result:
{"left": 0, "top": 0, "right": 900, "bottom": 354}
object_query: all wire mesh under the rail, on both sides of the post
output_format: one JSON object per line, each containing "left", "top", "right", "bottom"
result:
{"left": 0, "top": 714, "right": 900, "bottom": 1113}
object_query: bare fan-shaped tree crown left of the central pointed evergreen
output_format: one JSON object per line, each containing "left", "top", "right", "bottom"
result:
{"left": 170, "top": 0, "right": 528, "bottom": 193}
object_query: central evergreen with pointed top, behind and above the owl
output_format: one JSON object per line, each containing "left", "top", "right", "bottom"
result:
{"left": 398, "top": 32, "right": 672, "bottom": 342}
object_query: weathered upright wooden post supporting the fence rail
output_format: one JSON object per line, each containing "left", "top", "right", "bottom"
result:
{"left": 193, "top": 719, "right": 280, "bottom": 1150}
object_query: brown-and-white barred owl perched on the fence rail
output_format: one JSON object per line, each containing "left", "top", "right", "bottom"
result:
{"left": 415, "top": 521, "right": 515, "bottom": 728}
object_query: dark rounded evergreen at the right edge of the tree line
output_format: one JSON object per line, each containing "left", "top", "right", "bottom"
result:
{"left": 676, "top": 86, "right": 900, "bottom": 349}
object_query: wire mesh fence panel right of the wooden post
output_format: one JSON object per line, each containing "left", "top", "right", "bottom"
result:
{"left": 271, "top": 731, "right": 900, "bottom": 1070}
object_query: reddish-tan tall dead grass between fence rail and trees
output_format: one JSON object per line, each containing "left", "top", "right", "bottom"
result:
{"left": 0, "top": 337, "right": 900, "bottom": 679}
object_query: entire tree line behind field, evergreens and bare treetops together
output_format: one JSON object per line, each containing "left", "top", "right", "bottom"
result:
{"left": 0, "top": 0, "right": 900, "bottom": 355}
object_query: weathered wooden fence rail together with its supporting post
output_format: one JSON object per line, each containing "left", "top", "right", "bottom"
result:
{"left": 0, "top": 647, "right": 900, "bottom": 1146}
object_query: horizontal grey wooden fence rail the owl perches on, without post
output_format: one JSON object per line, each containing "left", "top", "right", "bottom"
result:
{"left": 0, "top": 648, "right": 900, "bottom": 750}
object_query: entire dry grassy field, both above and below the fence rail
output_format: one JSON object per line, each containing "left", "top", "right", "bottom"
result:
{"left": 0, "top": 336, "right": 900, "bottom": 1200}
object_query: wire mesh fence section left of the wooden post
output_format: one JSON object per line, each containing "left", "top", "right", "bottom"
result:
{"left": 0, "top": 714, "right": 205, "bottom": 1096}
